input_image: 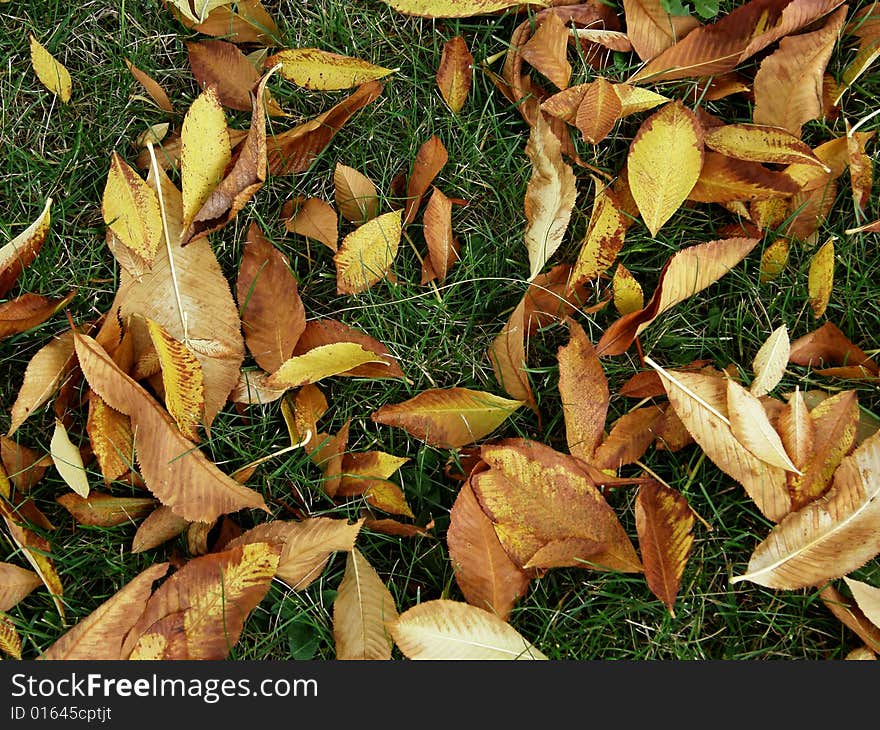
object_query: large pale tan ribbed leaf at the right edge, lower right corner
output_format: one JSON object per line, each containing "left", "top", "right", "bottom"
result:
{"left": 731, "top": 424, "right": 880, "bottom": 590}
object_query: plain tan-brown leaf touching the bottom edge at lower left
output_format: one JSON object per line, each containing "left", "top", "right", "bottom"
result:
{"left": 37, "top": 563, "right": 169, "bottom": 661}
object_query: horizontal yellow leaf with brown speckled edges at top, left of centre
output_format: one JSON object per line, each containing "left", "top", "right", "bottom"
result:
{"left": 265, "top": 48, "right": 397, "bottom": 91}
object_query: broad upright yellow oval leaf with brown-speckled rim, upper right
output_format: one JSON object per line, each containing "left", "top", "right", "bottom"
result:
{"left": 626, "top": 101, "right": 703, "bottom": 236}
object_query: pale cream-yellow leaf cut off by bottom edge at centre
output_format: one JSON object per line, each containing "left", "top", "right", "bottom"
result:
{"left": 391, "top": 598, "right": 547, "bottom": 660}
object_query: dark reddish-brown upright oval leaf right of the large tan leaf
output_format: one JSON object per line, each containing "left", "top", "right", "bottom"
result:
{"left": 236, "top": 222, "right": 306, "bottom": 373}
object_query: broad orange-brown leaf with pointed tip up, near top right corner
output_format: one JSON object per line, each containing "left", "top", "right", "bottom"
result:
{"left": 752, "top": 6, "right": 848, "bottom": 137}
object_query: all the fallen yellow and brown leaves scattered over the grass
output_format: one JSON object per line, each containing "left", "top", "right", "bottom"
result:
{"left": 0, "top": 0, "right": 880, "bottom": 659}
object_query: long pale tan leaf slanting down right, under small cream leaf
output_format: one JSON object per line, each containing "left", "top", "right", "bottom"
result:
{"left": 645, "top": 357, "right": 791, "bottom": 522}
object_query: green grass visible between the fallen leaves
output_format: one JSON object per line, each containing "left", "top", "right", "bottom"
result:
{"left": 0, "top": 0, "right": 880, "bottom": 660}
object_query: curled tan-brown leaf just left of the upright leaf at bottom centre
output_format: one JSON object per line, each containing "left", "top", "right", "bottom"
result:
{"left": 226, "top": 517, "right": 364, "bottom": 591}
